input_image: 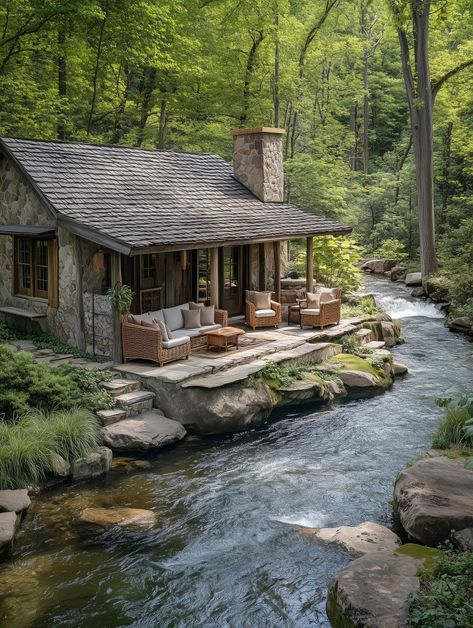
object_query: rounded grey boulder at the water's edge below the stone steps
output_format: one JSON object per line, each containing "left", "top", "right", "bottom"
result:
{"left": 102, "top": 410, "right": 186, "bottom": 451}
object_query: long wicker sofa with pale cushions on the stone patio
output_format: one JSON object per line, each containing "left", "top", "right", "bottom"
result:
{"left": 122, "top": 303, "right": 228, "bottom": 366}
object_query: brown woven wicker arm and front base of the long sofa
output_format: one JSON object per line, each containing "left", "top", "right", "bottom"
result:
{"left": 122, "top": 316, "right": 191, "bottom": 366}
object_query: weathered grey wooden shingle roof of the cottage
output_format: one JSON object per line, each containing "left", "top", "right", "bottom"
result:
{"left": 1, "top": 138, "right": 350, "bottom": 252}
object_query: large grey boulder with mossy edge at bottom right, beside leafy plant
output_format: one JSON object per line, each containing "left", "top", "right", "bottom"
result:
{"left": 327, "top": 551, "right": 423, "bottom": 628}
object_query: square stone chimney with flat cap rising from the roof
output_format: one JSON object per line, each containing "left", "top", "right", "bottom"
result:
{"left": 231, "top": 127, "right": 285, "bottom": 203}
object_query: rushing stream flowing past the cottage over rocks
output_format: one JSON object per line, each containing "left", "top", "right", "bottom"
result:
{"left": 0, "top": 278, "right": 473, "bottom": 628}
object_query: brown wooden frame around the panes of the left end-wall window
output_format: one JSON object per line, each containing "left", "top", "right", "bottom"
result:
{"left": 13, "top": 236, "right": 59, "bottom": 308}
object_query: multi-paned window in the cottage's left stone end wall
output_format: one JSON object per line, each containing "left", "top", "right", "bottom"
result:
{"left": 15, "top": 238, "right": 55, "bottom": 299}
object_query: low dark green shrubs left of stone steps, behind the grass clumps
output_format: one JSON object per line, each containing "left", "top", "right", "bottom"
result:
{"left": 0, "top": 346, "right": 113, "bottom": 421}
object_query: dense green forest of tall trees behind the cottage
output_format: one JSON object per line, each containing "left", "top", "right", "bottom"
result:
{"left": 0, "top": 0, "right": 473, "bottom": 315}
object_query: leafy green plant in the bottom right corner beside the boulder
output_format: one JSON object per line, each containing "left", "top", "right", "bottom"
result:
{"left": 409, "top": 550, "right": 473, "bottom": 628}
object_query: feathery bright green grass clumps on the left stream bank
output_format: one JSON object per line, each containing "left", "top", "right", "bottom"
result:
{"left": 0, "top": 409, "right": 101, "bottom": 490}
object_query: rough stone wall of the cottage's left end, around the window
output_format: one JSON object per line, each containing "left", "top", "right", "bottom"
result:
{"left": 0, "top": 157, "right": 111, "bottom": 354}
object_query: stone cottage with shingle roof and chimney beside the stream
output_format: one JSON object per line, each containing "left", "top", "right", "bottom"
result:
{"left": 0, "top": 128, "right": 350, "bottom": 355}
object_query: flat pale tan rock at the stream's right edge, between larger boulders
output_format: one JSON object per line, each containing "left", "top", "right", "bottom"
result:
{"left": 302, "top": 521, "right": 401, "bottom": 556}
